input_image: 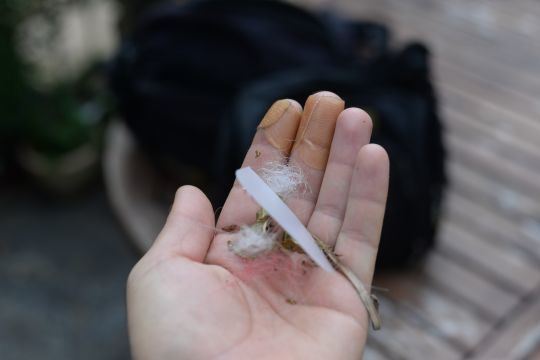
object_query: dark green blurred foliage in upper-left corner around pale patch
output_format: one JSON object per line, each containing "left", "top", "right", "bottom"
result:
{"left": 0, "top": 0, "right": 108, "bottom": 171}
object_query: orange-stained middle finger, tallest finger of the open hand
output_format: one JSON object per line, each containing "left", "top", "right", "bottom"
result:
{"left": 288, "top": 91, "right": 344, "bottom": 224}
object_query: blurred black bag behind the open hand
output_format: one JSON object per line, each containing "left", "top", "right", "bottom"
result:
{"left": 111, "top": 0, "right": 445, "bottom": 267}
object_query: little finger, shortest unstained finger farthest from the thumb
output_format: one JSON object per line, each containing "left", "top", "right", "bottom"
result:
{"left": 335, "top": 144, "right": 389, "bottom": 285}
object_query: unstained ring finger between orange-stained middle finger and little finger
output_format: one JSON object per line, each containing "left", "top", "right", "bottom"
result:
{"left": 308, "top": 108, "right": 372, "bottom": 246}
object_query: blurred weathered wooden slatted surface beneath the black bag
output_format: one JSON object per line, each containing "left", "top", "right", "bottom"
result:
{"left": 105, "top": 0, "right": 540, "bottom": 359}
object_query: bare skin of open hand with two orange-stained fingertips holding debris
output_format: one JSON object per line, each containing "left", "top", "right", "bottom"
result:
{"left": 127, "top": 92, "right": 389, "bottom": 359}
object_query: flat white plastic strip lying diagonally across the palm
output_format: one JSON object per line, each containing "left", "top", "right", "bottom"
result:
{"left": 236, "top": 167, "right": 334, "bottom": 271}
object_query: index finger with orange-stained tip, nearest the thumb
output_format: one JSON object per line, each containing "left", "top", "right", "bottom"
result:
{"left": 218, "top": 100, "right": 302, "bottom": 228}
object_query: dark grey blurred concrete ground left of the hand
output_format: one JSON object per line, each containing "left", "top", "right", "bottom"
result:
{"left": 0, "top": 185, "right": 137, "bottom": 360}
